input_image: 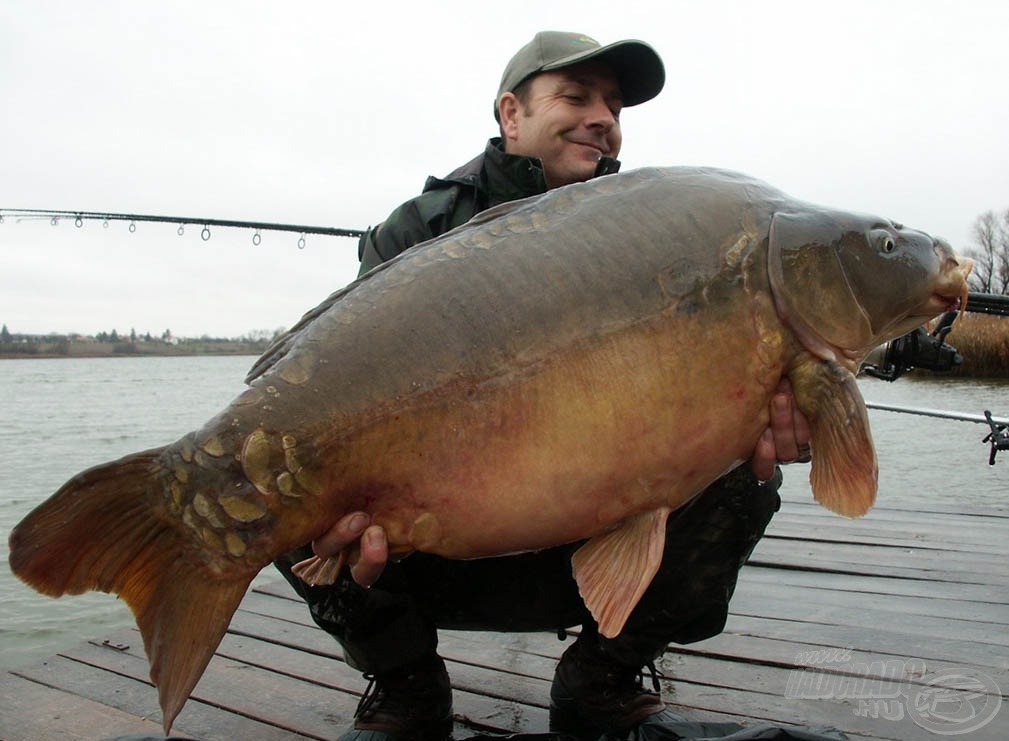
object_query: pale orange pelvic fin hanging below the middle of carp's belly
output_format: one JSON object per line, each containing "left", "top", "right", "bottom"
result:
{"left": 571, "top": 507, "right": 672, "bottom": 638}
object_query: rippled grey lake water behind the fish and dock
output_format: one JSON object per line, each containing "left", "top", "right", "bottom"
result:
{"left": 0, "top": 356, "right": 1009, "bottom": 668}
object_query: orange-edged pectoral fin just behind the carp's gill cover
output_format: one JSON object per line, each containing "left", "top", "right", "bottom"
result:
{"left": 789, "top": 358, "right": 879, "bottom": 517}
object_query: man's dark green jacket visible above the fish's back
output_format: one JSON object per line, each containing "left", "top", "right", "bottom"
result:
{"left": 357, "top": 137, "right": 621, "bottom": 275}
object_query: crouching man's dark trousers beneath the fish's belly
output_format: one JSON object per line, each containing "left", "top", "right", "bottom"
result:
{"left": 275, "top": 465, "right": 781, "bottom": 674}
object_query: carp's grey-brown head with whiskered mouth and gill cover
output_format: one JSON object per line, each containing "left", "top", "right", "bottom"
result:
{"left": 768, "top": 208, "right": 974, "bottom": 373}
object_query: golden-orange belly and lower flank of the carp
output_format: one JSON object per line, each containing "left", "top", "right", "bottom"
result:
{"left": 334, "top": 304, "right": 780, "bottom": 558}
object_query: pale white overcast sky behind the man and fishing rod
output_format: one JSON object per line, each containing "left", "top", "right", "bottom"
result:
{"left": 0, "top": 0, "right": 1009, "bottom": 336}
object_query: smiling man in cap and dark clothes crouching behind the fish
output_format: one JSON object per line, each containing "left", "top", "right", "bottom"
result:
{"left": 277, "top": 31, "right": 808, "bottom": 739}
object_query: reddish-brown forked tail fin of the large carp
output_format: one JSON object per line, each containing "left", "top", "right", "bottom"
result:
{"left": 9, "top": 448, "right": 254, "bottom": 734}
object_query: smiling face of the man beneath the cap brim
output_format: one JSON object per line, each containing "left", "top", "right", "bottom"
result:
{"left": 499, "top": 62, "right": 623, "bottom": 188}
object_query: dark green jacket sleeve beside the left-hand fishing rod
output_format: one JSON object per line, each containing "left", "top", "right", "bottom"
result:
{"left": 357, "top": 187, "right": 473, "bottom": 276}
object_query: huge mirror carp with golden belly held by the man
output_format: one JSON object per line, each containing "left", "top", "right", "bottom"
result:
{"left": 10, "top": 169, "right": 971, "bottom": 731}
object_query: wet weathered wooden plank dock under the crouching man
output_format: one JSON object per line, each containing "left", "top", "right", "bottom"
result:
{"left": 0, "top": 492, "right": 1009, "bottom": 741}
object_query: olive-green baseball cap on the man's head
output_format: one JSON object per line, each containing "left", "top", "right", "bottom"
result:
{"left": 494, "top": 31, "right": 666, "bottom": 117}
